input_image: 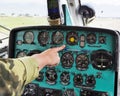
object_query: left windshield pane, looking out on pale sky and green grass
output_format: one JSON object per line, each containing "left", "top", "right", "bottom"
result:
{"left": 0, "top": 0, "right": 48, "bottom": 48}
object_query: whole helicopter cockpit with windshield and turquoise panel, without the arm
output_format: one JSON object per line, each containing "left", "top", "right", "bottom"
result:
{"left": 0, "top": 0, "right": 120, "bottom": 96}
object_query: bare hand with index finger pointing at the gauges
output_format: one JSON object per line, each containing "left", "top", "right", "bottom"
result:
{"left": 32, "top": 45, "right": 65, "bottom": 69}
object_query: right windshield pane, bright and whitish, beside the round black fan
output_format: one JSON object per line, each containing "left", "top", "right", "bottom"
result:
{"left": 81, "top": 0, "right": 120, "bottom": 31}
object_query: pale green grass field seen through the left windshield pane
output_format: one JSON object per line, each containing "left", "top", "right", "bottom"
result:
{"left": 0, "top": 16, "right": 48, "bottom": 34}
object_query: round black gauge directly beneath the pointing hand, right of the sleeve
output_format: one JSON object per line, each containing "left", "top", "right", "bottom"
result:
{"left": 46, "top": 69, "right": 57, "bottom": 84}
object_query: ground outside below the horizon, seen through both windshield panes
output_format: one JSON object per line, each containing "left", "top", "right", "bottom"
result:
{"left": 0, "top": 16, "right": 120, "bottom": 34}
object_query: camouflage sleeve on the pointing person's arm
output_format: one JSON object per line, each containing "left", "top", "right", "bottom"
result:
{"left": 0, "top": 57, "right": 39, "bottom": 96}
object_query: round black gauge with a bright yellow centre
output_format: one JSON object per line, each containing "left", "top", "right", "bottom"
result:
{"left": 66, "top": 32, "right": 78, "bottom": 45}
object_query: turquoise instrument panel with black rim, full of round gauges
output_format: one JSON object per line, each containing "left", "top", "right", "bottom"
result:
{"left": 9, "top": 26, "right": 119, "bottom": 96}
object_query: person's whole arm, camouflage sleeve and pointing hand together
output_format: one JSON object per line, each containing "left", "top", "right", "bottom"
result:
{"left": 0, "top": 45, "right": 65, "bottom": 96}
